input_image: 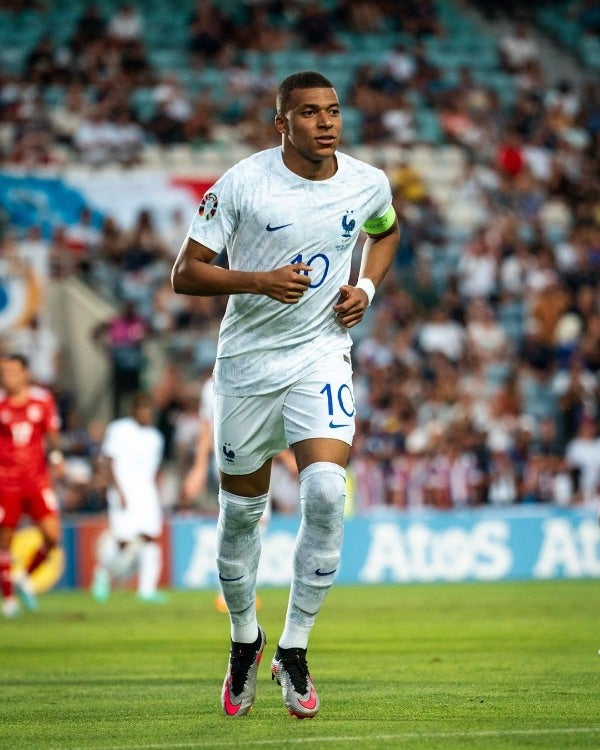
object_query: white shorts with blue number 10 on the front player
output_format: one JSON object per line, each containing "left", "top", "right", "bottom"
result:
{"left": 214, "top": 354, "right": 356, "bottom": 475}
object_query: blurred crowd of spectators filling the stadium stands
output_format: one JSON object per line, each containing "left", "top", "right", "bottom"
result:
{"left": 0, "top": 0, "right": 600, "bottom": 512}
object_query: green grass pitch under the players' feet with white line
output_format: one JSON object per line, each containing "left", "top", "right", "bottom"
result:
{"left": 0, "top": 581, "right": 600, "bottom": 750}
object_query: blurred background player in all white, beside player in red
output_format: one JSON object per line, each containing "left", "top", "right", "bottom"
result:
{"left": 92, "top": 393, "right": 167, "bottom": 604}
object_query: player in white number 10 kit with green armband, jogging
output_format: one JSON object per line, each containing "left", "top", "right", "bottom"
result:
{"left": 172, "top": 71, "right": 399, "bottom": 718}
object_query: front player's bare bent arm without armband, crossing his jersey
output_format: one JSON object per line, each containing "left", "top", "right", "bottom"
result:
{"left": 171, "top": 237, "right": 312, "bottom": 305}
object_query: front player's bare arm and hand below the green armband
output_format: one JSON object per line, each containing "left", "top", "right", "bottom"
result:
{"left": 333, "top": 221, "right": 400, "bottom": 328}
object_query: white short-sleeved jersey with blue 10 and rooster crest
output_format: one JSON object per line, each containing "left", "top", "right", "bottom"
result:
{"left": 189, "top": 147, "right": 392, "bottom": 396}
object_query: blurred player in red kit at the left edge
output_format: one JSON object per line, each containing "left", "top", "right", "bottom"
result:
{"left": 0, "top": 354, "right": 63, "bottom": 617}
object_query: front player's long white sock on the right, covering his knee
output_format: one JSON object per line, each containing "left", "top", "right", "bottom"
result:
{"left": 279, "top": 461, "right": 346, "bottom": 648}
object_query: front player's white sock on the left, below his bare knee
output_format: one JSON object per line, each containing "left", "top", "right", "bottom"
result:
{"left": 217, "top": 489, "right": 268, "bottom": 643}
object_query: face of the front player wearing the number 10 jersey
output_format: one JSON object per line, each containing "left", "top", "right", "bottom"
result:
{"left": 275, "top": 88, "right": 342, "bottom": 164}
